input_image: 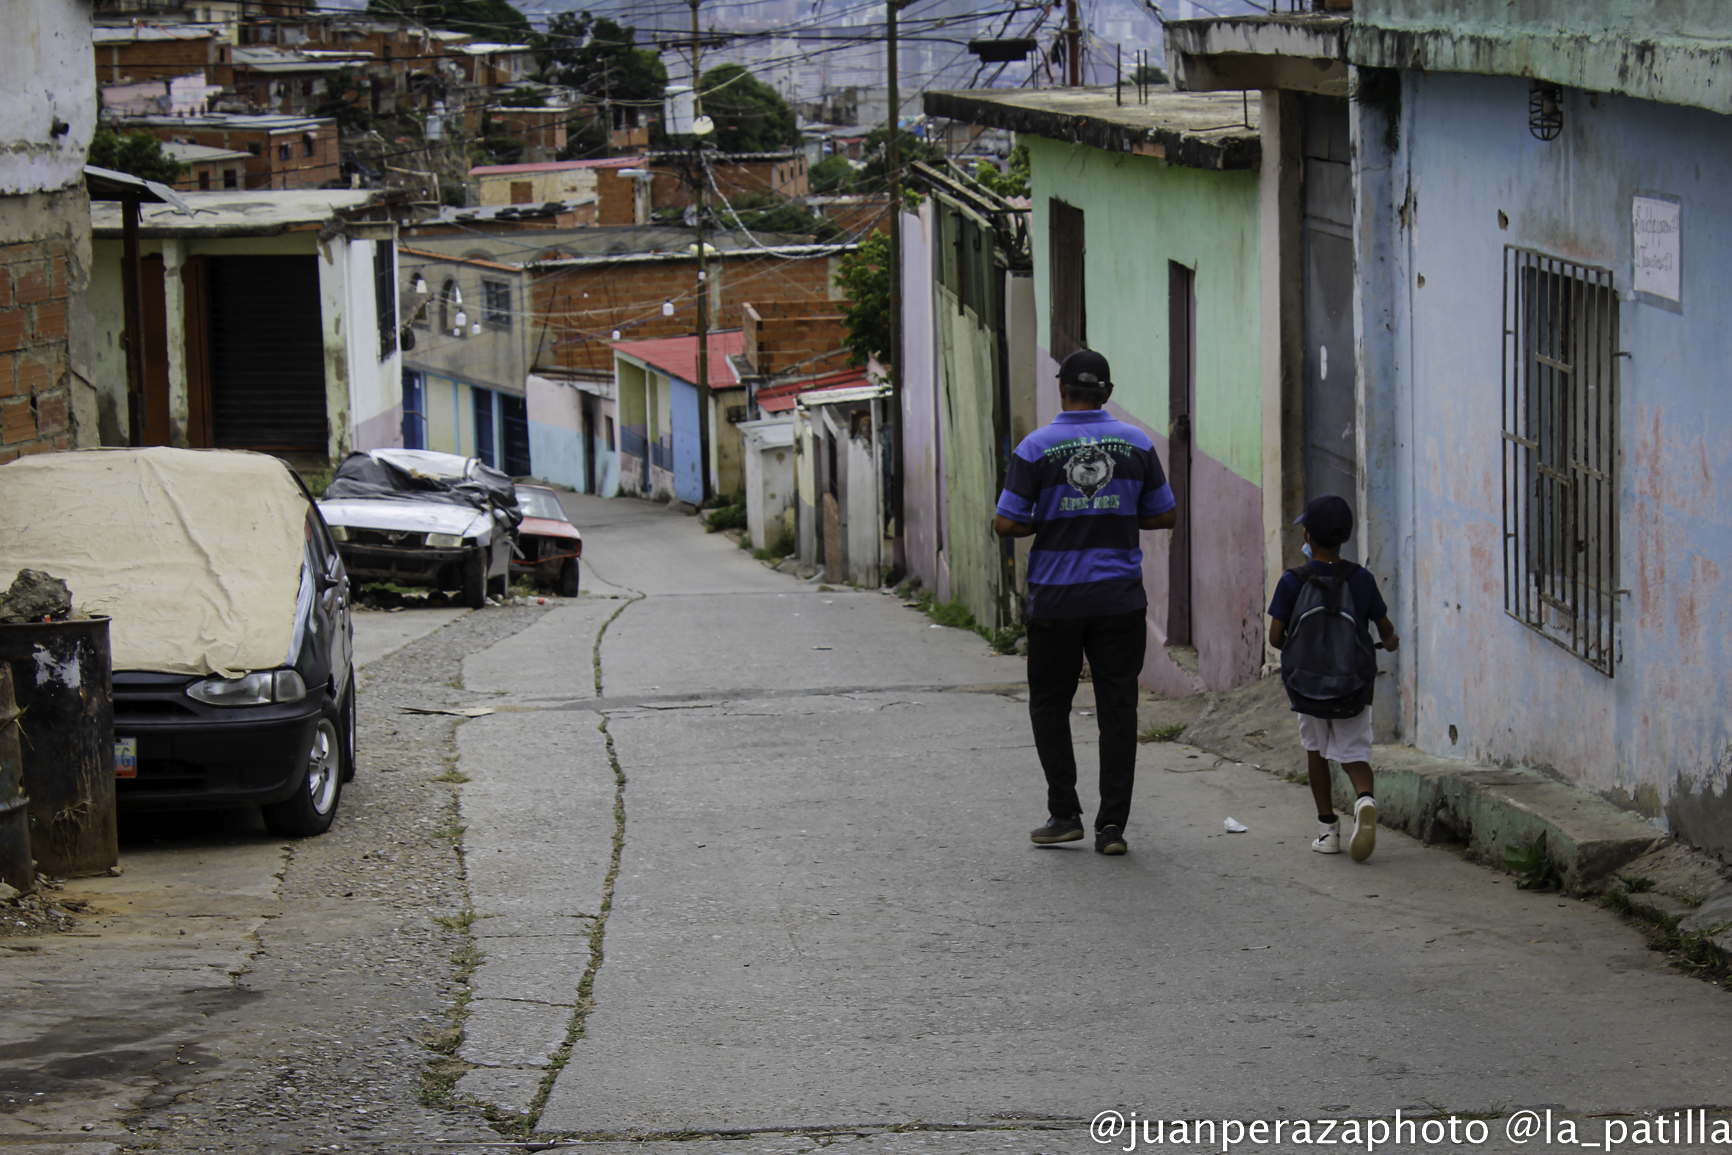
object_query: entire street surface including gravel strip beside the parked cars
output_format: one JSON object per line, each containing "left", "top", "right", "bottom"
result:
{"left": 0, "top": 497, "right": 1732, "bottom": 1155}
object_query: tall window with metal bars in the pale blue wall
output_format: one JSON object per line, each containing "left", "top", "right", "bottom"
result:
{"left": 1503, "top": 248, "right": 1618, "bottom": 677}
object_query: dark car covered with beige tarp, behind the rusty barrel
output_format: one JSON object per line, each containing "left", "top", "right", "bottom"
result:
{"left": 0, "top": 447, "right": 355, "bottom": 836}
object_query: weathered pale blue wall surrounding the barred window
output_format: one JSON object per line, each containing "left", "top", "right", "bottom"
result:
{"left": 1385, "top": 73, "right": 1732, "bottom": 850}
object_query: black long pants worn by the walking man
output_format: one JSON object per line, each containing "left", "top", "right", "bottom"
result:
{"left": 1029, "top": 610, "right": 1148, "bottom": 829}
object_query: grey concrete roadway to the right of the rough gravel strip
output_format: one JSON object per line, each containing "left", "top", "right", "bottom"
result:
{"left": 459, "top": 497, "right": 1732, "bottom": 1150}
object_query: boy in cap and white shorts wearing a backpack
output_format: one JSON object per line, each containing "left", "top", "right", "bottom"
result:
{"left": 1270, "top": 495, "right": 1401, "bottom": 862}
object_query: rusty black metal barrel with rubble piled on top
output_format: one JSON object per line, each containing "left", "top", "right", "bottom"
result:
{"left": 0, "top": 618, "right": 120, "bottom": 878}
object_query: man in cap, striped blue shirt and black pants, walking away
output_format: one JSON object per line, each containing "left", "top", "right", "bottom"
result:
{"left": 992, "top": 350, "right": 1178, "bottom": 854}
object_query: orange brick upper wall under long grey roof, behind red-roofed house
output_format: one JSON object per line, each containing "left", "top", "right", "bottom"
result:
{"left": 528, "top": 244, "right": 842, "bottom": 376}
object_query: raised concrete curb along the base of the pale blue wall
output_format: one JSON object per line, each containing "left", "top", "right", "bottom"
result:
{"left": 1334, "top": 746, "right": 1670, "bottom": 894}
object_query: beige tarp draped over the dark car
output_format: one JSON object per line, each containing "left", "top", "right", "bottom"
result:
{"left": 0, "top": 448, "right": 307, "bottom": 675}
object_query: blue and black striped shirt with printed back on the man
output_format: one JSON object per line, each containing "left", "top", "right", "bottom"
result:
{"left": 998, "top": 409, "right": 1174, "bottom": 618}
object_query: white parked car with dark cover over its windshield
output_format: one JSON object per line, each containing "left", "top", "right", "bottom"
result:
{"left": 319, "top": 448, "right": 523, "bottom": 610}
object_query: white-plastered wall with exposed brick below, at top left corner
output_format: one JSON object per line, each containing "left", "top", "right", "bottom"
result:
{"left": 0, "top": 0, "right": 102, "bottom": 462}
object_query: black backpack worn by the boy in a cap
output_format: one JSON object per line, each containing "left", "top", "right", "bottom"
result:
{"left": 1282, "top": 561, "right": 1377, "bottom": 719}
